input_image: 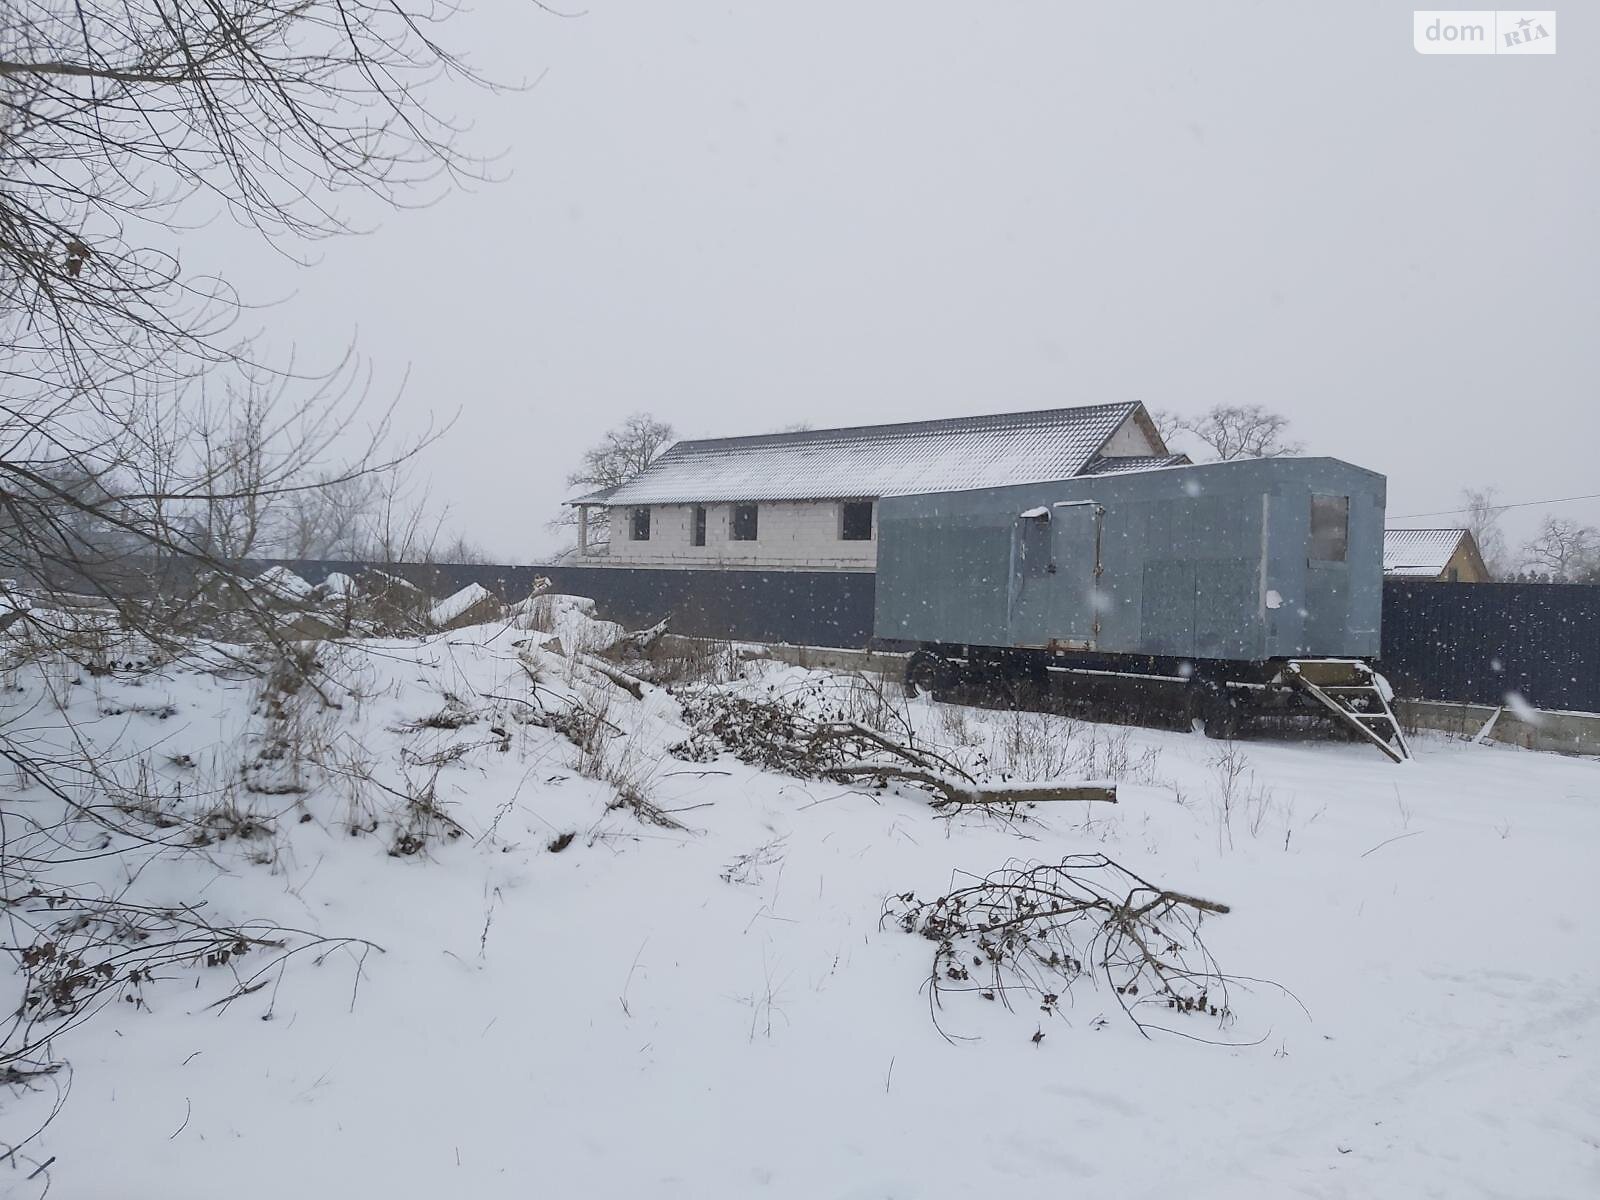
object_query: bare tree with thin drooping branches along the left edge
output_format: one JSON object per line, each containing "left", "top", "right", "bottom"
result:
{"left": 0, "top": 0, "right": 534, "bottom": 1120}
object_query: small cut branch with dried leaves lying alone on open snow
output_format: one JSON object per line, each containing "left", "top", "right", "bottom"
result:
{"left": 883, "top": 854, "right": 1232, "bottom": 1035}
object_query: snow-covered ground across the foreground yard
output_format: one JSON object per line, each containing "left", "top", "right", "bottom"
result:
{"left": 0, "top": 627, "right": 1600, "bottom": 1200}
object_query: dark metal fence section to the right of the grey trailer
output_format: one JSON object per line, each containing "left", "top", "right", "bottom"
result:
{"left": 1382, "top": 581, "right": 1600, "bottom": 712}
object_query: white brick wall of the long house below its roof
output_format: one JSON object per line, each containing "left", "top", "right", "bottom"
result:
{"left": 594, "top": 501, "right": 878, "bottom": 571}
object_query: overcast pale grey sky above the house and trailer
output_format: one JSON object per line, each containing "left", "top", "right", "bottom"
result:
{"left": 232, "top": 0, "right": 1600, "bottom": 560}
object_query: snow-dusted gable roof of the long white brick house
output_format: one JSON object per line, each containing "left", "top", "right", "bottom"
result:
{"left": 568, "top": 402, "right": 1160, "bottom": 504}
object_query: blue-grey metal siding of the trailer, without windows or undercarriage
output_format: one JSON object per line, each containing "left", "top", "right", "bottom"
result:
{"left": 877, "top": 459, "right": 1384, "bottom": 661}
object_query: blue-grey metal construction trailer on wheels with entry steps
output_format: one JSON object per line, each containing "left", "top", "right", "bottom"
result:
{"left": 874, "top": 458, "right": 1403, "bottom": 752}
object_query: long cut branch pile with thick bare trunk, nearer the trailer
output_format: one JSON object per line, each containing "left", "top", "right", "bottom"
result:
{"left": 670, "top": 690, "right": 1117, "bottom": 808}
